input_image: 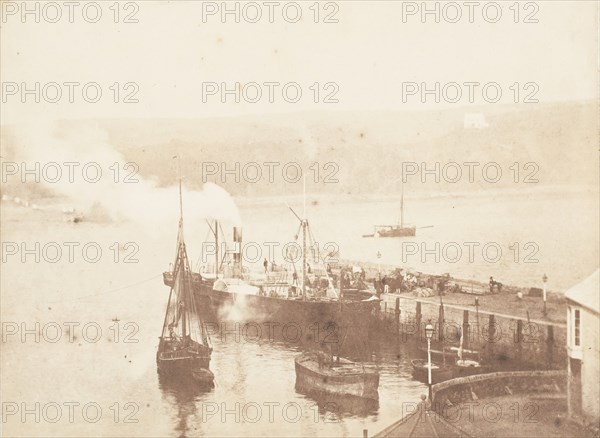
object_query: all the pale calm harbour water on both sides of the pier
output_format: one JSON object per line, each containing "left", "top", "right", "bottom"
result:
{"left": 1, "top": 190, "right": 598, "bottom": 436}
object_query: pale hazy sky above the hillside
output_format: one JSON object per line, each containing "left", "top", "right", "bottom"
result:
{"left": 0, "top": 1, "right": 598, "bottom": 123}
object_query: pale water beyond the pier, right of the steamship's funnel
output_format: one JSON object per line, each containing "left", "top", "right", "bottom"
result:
{"left": 241, "top": 187, "right": 600, "bottom": 291}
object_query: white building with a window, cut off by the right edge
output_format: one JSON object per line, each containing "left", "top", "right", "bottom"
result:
{"left": 566, "top": 271, "right": 600, "bottom": 421}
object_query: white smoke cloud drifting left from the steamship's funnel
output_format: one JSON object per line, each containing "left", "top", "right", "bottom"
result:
{"left": 7, "top": 121, "right": 241, "bottom": 227}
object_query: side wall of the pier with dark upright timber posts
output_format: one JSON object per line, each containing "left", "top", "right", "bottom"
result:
{"left": 376, "top": 297, "right": 567, "bottom": 369}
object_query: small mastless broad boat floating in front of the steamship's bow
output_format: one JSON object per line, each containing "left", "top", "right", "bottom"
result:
{"left": 294, "top": 352, "right": 379, "bottom": 400}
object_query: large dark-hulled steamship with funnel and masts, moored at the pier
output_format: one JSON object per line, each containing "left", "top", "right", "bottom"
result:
{"left": 163, "top": 214, "right": 380, "bottom": 336}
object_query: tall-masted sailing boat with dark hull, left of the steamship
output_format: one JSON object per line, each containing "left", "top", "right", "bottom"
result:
{"left": 156, "top": 179, "right": 214, "bottom": 386}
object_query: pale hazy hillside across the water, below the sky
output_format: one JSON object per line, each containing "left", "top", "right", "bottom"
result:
{"left": 2, "top": 102, "right": 599, "bottom": 196}
